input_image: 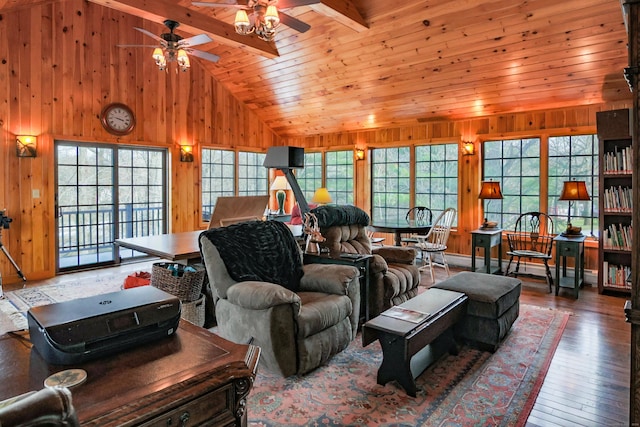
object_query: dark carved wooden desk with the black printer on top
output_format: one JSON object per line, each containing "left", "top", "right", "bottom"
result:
{"left": 0, "top": 321, "right": 260, "bottom": 427}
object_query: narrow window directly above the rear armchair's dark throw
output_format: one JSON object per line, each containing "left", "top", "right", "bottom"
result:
{"left": 325, "top": 150, "right": 353, "bottom": 205}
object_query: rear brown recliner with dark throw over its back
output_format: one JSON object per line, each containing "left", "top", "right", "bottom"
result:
{"left": 311, "top": 205, "right": 420, "bottom": 317}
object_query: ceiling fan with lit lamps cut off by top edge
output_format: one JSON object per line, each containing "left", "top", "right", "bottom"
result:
{"left": 191, "top": 0, "right": 320, "bottom": 42}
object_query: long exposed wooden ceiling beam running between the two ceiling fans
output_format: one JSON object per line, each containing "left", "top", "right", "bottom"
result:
{"left": 89, "top": 0, "right": 279, "bottom": 58}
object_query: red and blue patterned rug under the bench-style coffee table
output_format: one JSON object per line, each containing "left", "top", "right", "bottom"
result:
{"left": 247, "top": 304, "right": 569, "bottom": 427}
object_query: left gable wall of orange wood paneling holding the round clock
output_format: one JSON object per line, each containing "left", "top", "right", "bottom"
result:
{"left": 0, "top": 0, "right": 280, "bottom": 282}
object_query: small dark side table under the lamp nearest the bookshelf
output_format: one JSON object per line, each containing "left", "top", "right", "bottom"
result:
{"left": 553, "top": 234, "right": 586, "bottom": 298}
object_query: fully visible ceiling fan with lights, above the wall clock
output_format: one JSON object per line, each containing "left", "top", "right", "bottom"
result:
{"left": 118, "top": 19, "right": 220, "bottom": 71}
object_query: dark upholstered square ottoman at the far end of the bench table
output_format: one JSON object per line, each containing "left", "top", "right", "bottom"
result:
{"left": 433, "top": 272, "right": 522, "bottom": 351}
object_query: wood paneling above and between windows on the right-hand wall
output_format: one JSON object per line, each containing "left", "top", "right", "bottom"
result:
{"left": 284, "top": 102, "right": 630, "bottom": 276}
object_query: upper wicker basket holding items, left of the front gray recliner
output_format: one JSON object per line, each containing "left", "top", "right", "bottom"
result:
{"left": 151, "top": 262, "right": 206, "bottom": 302}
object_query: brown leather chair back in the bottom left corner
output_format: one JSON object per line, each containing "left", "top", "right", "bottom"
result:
{"left": 0, "top": 387, "right": 80, "bottom": 427}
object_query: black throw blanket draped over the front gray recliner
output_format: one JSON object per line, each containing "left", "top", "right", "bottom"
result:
{"left": 198, "top": 221, "right": 304, "bottom": 292}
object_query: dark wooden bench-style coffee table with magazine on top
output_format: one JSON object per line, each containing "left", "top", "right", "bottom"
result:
{"left": 362, "top": 289, "right": 467, "bottom": 397}
